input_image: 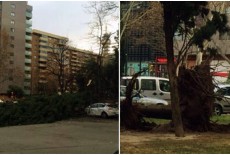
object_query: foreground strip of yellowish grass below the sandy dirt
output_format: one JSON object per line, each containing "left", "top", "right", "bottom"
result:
{"left": 121, "top": 133, "right": 230, "bottom": 154}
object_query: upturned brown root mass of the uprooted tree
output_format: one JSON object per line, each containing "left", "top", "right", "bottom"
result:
{"left": 178, "top": 64, "right": 214, "bottom": 131}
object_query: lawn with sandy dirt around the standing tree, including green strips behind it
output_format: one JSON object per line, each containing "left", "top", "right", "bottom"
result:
{"left": 120, "top": 115, "right": 230, "bottom": 154}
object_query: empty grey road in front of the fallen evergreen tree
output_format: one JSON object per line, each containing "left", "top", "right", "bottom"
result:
{"left": 0, "top": 118, "right": 119, "bottom": 154}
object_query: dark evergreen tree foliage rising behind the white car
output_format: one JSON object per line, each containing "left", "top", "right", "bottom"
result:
{"left": 75, "top": 48, "right": 119, "bottom": 102}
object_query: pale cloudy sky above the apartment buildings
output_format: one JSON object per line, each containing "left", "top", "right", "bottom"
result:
{"left": 28, "top": 1, "right": 119, "bottom": 53}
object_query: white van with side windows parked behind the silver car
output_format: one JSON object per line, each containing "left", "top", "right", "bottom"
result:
{"left": 121, "top": 76, "right": 171, "bottom": 103}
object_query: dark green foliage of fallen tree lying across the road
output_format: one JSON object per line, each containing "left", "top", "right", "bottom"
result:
{"left": 0, "top": 94, "right": 89, "bottom": 126}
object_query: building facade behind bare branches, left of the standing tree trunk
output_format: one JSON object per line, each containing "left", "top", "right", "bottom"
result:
{"left": 120, "top": 1, "right": 166, "bottom": 76}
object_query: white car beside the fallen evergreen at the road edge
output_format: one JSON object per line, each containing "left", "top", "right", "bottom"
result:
{"left": 85, "top": 103, "right": 119, "bottom": 118}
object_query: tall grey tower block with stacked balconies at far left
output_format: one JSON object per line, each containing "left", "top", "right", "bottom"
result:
{"left": 0, "top": 1, "right": 32, "bottom": 94}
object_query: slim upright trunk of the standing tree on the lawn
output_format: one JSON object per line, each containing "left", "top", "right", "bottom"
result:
{"left": 163, "top": 2, "right": 184, "bottom": 137}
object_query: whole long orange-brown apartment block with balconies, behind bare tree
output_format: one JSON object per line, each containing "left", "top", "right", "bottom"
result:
{"left": 31, "top": 30, "right": 97, "bottom": 94}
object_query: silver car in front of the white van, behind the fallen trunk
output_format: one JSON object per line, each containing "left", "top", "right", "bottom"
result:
{"left": 120, "top": 86, "right": 169, "bottom": 106}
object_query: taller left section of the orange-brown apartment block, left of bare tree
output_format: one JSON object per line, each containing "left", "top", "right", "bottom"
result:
{"left": 31, "top": 30, "right": 68, "bottom": 94}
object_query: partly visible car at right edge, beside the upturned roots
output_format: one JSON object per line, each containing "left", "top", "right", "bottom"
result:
{"left": 214, "top": 84, "right": 230, "bottom": 115}
